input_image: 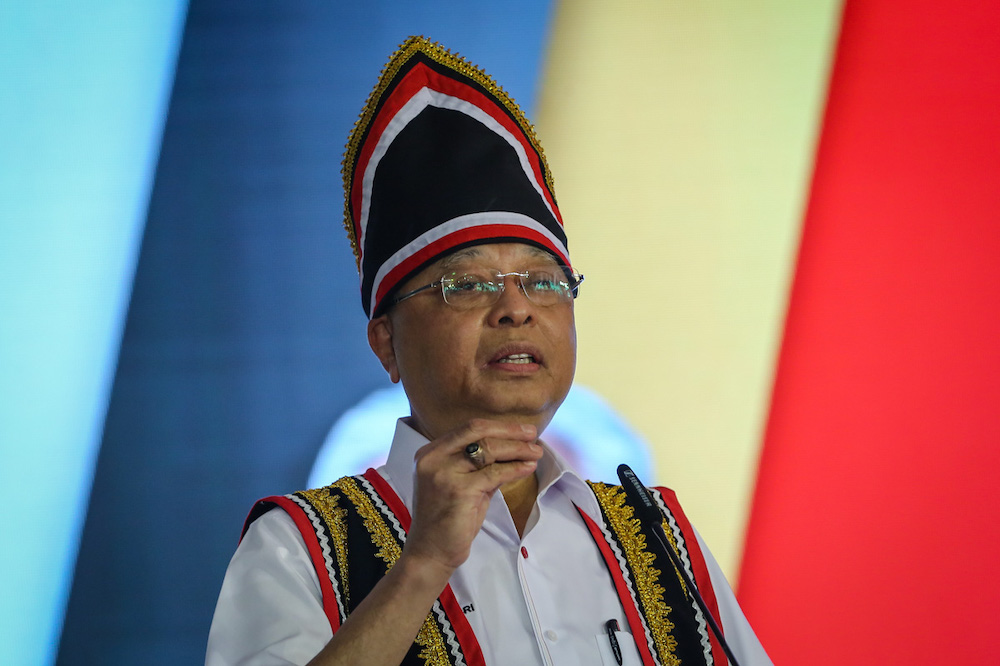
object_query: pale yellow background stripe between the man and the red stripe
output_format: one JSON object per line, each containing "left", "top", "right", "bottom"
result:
{"left": 536, "top": 0, "right": 840, "bottom": 580}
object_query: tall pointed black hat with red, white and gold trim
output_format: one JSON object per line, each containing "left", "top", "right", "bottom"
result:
{"left": 343, "top": 37, "right": 570, "bottom": 317}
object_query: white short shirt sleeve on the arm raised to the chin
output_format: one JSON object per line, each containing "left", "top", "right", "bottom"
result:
{"left": 205, "top": 508, "right": 333, "bottom": 666}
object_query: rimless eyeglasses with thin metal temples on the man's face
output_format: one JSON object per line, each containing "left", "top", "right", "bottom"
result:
{"left": 387, "top": 266, "right": 583, "bottom": 310}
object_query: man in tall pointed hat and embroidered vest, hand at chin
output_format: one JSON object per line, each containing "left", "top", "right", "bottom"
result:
{"left": 207, "top": 38, "right": 770, "bottom": 666}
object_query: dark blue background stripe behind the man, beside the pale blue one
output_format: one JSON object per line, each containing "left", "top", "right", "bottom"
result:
{"left": 58, "top": 0, "right": 549, "bottom": 664}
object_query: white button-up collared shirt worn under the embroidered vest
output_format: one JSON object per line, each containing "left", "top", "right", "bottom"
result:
{"left": 206, "top": 420, "right": 770, "bottom": 666}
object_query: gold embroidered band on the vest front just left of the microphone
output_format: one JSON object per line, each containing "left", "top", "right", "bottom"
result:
{"left": 587, "top": 481, "right": 681, "bottom": 666}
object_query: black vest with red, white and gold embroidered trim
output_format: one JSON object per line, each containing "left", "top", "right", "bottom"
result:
{"left": 243, "top": 469, "right": 727, "bottom": 666}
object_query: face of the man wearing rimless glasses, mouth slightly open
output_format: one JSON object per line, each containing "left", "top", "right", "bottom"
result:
{"left": 368, "top": 243, "right": 576, "bottom": 439}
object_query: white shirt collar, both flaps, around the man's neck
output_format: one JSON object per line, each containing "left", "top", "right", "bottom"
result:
{"left": 384, "top": 419, "right": 601, "bottom": 516}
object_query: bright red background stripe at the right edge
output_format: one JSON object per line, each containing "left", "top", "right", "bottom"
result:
{"left": 739, "top": 0, "right": 1000, "bottom": 664}
